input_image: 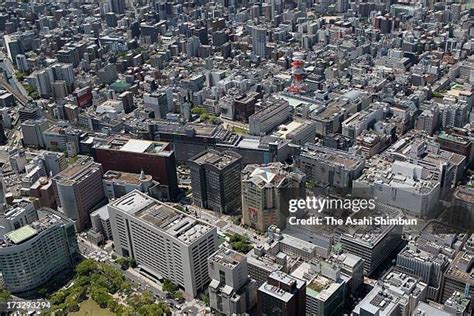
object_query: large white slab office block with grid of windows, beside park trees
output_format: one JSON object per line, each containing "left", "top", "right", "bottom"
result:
{"left": 108, "top": 191, "right": 217, "bottom": 296}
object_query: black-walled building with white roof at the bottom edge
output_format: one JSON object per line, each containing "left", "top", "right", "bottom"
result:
{"left": 257, "top": 271, "right": 306, "bottom": 316}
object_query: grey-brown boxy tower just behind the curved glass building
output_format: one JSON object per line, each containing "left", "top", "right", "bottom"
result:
{"left": 53, "top": 157, "right": 106, "bottom": 232}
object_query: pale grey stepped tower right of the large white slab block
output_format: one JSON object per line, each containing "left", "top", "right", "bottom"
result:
{"left": 207, "top": 247, "right": 257, "bottom": 315}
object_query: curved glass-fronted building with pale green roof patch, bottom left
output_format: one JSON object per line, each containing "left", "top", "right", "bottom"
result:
{"left": 0, "top": 209, "right": 79, "bottom": 293}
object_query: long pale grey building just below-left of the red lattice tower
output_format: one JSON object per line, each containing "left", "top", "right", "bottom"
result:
{"left": 249, "top": 99, "right": 290, "bottom": 135}
